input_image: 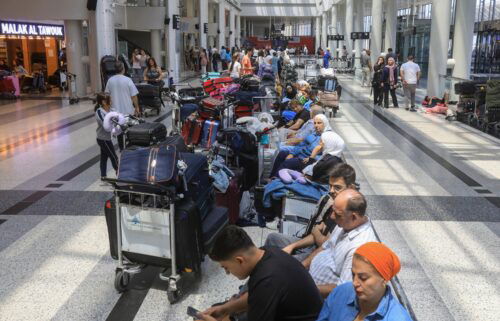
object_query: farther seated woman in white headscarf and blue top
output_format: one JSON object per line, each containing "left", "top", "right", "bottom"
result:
{"left": 271, "top": 114, "right": 332, "bottom": 177}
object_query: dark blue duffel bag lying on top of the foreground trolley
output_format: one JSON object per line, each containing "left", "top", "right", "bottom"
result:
{"left": 118, "top": 145, "right": 179, "bottom": 184}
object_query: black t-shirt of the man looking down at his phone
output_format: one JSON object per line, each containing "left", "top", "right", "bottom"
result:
{"left": 248, "top": 247, "right": 322, "bottom": 321}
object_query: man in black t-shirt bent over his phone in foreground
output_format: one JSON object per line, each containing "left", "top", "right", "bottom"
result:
{"left": 195, "top": 225, "right": 322, "bottom": 321}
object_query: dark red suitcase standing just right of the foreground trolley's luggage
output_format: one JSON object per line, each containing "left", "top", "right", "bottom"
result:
{"left": 215, "top": 169, "right": 244, "bottom": 224}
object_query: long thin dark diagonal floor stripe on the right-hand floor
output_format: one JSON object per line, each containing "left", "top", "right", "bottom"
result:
{"left": 345, "top": 85, "right": 482, "bottom": 187}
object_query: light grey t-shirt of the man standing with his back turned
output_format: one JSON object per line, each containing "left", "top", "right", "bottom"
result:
{"left": 105, "top": 75, "right": 139, "bottom": 114}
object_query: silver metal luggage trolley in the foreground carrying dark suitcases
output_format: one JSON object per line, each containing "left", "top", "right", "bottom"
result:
{"left": 106, "top": 179, "right": 197, "bottom": 304}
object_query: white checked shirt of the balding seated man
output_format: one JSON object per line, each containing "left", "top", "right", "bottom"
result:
{"left": 309, "top": 220, "right": 377, "bottom": 285}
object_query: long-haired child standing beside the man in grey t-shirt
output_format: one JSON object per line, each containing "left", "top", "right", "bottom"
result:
{"left": 94, "top": 93, "right": 118, "bottom": 179}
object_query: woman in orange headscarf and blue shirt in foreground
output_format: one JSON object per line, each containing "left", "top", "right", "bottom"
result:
{"left": 317, "top": 242, "right": 412, "bottom": 321}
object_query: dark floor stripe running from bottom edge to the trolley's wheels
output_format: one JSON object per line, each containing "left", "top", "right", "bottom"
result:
{"left": 106, "top": 267, "right": 160, "bottom": 321}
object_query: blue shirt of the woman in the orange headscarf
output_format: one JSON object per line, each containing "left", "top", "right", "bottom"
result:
{"left": 318, "top": 282, "right": 412, "bottom": 321}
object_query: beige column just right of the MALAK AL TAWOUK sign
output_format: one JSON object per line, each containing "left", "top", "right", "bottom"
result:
{"left": 64, "top": 20, "right": 87, "bottom": 97}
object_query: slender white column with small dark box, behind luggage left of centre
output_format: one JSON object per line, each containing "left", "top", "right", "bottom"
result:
{"left": 165, "top": 0, "right": 181, "bottom": 82}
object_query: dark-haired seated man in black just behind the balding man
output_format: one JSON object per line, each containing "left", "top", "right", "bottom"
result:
{"left": 265, "top": 163, "right": 356, "bottom": 262}
